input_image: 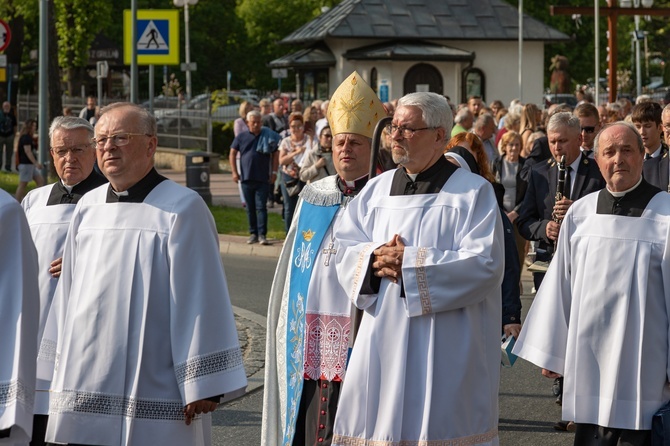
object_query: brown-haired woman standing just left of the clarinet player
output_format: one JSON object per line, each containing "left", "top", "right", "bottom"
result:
{"left": 493, "top": 132, "right": 535, "bottom": 267}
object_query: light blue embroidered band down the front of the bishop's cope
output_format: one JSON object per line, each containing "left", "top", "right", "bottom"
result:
{"left": 283, "top": 200, "right": 340, "bottom": 446}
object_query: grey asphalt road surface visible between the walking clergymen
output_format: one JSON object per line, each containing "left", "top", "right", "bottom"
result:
{"left": 212, "top": 255, "right": 573, "bottom": 446}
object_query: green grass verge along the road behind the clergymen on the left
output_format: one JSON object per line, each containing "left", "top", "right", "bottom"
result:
{"left": 0, "top": 172, "right": 286, "bottom": 240}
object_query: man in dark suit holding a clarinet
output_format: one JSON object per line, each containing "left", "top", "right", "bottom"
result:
{"left": 517, "top": 112, "right": 605, "bottom": 289}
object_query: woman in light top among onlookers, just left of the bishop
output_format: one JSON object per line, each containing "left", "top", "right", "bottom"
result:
{"left": 279, "top": 112, "right": 313, "bottom": 232}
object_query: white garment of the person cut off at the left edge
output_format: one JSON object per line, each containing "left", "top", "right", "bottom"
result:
{"left": 0, "top": 190, "right": 40, "bottom": 446}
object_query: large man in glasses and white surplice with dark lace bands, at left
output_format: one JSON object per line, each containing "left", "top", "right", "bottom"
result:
{"left": 38, "top": 103, "right": 246, "bottom": 446}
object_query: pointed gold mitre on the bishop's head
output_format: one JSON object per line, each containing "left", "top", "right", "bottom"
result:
{"left": 328, "top": 71, "right": 386, "bottom": 138}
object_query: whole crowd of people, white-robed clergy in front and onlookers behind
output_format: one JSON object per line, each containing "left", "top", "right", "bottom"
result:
{"left": 0, "top": 76, "right": 670, "bottom": 446}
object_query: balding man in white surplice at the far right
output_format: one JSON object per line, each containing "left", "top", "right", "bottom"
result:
{"left": 513, "top": 122, "right": 670, "bottom": 446}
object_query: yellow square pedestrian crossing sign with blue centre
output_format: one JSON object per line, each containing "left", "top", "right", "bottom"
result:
{"left": 123, "top": 9, "right": 180, "bottom": 65}
